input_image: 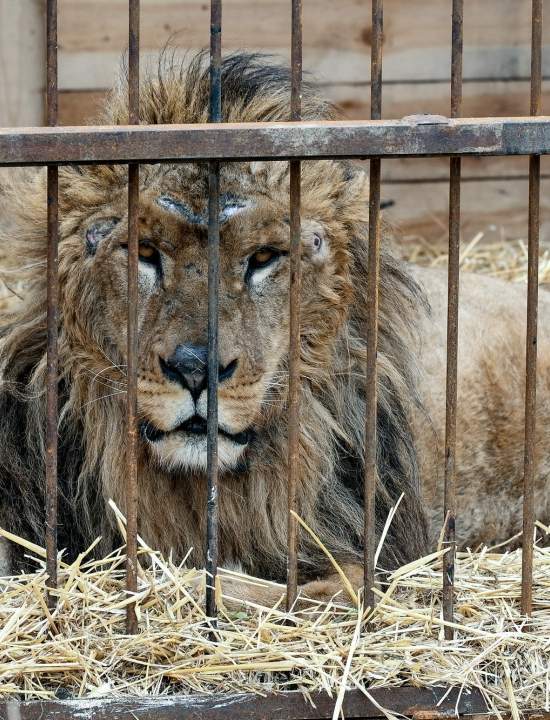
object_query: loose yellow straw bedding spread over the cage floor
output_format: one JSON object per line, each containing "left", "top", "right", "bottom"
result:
{"left": 0, "top": 236, "right": 550, "bottom": 718}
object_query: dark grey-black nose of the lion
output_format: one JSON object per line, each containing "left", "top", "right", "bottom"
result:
{"left": 160, "top": 345, "right": 237, "bottom": 401}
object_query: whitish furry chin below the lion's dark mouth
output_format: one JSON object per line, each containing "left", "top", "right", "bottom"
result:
{"left": 150, "top": 433, "right": 247, "bottom": 472}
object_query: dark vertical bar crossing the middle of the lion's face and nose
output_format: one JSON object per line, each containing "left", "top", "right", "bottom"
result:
{"left": 206, "top": 0, "right": 222, "bottom": 618}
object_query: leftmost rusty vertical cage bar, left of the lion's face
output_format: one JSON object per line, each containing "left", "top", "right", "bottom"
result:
{"left": 46, "top": 0, "right": 59, "bottom": 607}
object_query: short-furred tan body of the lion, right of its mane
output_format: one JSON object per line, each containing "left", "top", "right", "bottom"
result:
{"left": 411, "top": 268, "right": 550, "bottom": 547}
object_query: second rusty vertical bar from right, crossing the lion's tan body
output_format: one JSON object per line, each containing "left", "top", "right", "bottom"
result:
{"left": 443, "top": 0, "right": 464, "bottom": 640}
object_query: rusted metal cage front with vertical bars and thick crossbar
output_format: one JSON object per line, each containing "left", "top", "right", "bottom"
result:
{"left": 0, "top": 0, "right": 550, "bottom": 718}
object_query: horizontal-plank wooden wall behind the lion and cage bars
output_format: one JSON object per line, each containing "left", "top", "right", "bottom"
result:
{"left": 0, "top": 0, "right": 550, "bottom": 238}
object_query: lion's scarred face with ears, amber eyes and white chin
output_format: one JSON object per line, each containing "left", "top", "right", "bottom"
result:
{"left": 66, "top": 163, "right": 358, "bottom": 469}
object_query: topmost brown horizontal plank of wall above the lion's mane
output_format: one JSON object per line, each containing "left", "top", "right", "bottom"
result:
{"left": 59, "top": 0, "right": 544, "bottom": 56}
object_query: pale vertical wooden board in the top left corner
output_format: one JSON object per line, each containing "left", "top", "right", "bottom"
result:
{"left": 0, "top": 0, "right": 46, "bottom": 127}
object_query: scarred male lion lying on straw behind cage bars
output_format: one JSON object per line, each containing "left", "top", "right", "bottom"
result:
{"left": 0, "top": 53, "right": 550, "bottom": 602}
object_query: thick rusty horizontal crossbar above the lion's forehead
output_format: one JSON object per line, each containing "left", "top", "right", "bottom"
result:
{"left": 0, "top": 115, "right": 550, "bottom": 166}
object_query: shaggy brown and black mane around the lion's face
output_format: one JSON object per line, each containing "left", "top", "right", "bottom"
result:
{"left": 0, "top": 54, "right": 426, "bottom": 579}
